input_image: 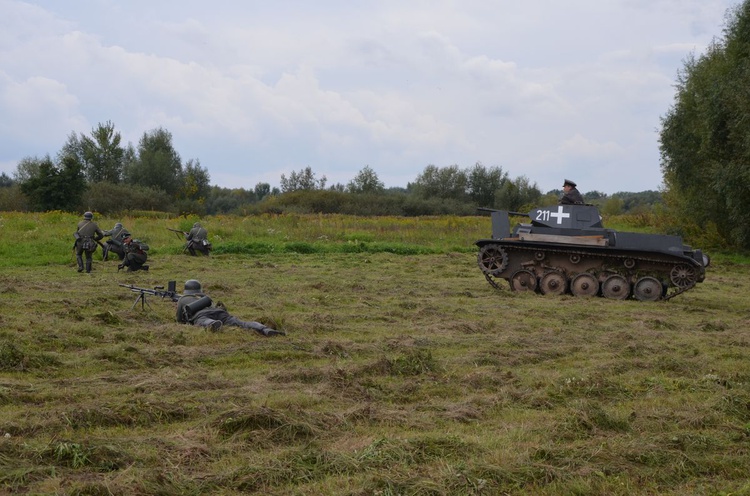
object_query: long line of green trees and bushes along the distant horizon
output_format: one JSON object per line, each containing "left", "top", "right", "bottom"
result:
{"left": 0, "top": 121, "right": 660, "bottom": 216}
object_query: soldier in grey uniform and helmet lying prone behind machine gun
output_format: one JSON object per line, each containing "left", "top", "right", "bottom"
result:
{"left": 177, "top": 279, "right": 286, "bottom": 337}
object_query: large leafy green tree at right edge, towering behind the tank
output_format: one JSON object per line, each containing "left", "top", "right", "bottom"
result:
{"left": 659, "top": 0, "right": 750, "bottom": 248}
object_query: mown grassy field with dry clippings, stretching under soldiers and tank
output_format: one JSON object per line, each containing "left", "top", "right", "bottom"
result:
{"left": 0, "top": 213, "right": 750, "bottom": 495}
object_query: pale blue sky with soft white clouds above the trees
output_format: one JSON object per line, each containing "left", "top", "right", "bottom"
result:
{"left": 0, "top": 0, "right": 740, "bottom": 194}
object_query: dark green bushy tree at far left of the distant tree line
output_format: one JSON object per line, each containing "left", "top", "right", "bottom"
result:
{"left": 19, "top": 155, "right": 86, "bottom": 212}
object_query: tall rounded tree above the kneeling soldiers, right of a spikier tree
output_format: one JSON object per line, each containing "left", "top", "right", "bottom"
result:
{"left": 124, "top": 128, "right": 182, "bottom": 198}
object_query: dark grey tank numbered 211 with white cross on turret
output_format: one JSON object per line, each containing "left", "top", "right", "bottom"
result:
{"left": 476, "top": 205, "right": 710, "bottom": 301}
